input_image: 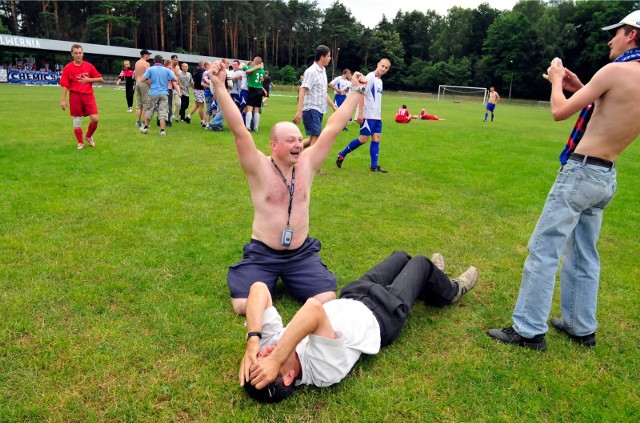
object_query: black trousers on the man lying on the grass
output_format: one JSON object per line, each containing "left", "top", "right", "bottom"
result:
{"left": 340, "top": 251, "right": 458, "bottom": 347}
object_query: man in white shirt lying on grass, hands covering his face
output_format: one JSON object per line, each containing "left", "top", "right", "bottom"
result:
{"left": 239, "top": 252, "right": 478, "bottom": 403}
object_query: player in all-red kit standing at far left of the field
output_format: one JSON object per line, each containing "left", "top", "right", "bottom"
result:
{"left": 60, "top": 44, "right": 104, "bottom": 150}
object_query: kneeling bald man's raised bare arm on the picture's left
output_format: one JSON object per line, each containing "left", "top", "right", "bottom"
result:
{"left": 209, "top": 62, "right": 263, "bottom": 175}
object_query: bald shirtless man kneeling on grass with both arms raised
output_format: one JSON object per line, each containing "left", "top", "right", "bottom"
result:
{"left": 209, "top": 62, "right": 364, "bottom": 314}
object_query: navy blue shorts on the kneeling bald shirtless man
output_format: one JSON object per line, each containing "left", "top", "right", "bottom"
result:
{"left": 227, "top": 238, "right": 338, "bottom": 301}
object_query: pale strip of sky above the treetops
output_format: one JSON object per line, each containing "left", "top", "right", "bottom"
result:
{"left": 316, "top": 0, "right": 517, "bottom": 28}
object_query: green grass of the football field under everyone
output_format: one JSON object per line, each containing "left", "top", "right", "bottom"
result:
{"left": 0, "top": 84, "right": 640, "bottom": 422}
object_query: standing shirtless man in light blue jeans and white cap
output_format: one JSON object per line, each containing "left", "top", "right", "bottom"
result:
{"left": 487, "top": 10, "right": 640, "bottom": 350}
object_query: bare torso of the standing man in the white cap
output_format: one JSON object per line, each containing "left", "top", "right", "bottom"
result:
{"left": 575, "top": 62, "right": 640, "bottom": 161}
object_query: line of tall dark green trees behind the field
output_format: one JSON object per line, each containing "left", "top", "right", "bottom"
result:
{"left": 0, "top": 0, "right": 640, "bottom": 99}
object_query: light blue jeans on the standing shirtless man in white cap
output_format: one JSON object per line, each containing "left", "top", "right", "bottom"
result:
{"left": 513, "top": 160, "right": 616, "bottom": 338}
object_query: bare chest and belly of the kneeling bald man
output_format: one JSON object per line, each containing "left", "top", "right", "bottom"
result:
{"left": 247, "top": 156, "right": 315, "bottom": 250}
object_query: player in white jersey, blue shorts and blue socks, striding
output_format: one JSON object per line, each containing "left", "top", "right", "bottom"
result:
{"left": 336, "top": 58, "right": 391, "bottom": 173}
